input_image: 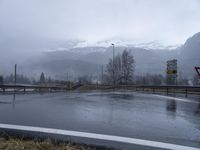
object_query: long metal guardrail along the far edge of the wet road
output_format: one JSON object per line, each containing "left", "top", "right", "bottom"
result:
{"left": 0, "top": 84, "right": 200, "bottom": 97}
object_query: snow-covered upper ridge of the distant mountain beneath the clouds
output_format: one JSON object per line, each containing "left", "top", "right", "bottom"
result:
{"left": 43, "top": 39, "right": 181, "bottom": 54}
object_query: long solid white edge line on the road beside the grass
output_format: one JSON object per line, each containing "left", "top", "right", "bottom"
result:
{"left": 0, "top": 124, "right": 200, "bottom": 150}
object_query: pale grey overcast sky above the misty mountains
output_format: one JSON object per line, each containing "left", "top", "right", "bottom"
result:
{"left": 0, "top": 0, "right": 200, "bottom": 45}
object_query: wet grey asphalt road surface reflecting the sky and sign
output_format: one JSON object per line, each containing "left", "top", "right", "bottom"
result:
{"left": 0, "top": 91, "right": 200, "bottom": 149}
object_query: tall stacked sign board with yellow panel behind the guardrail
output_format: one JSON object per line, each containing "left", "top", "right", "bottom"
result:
{"left": 167, "top": 59, "right": 177, "bottom": 85}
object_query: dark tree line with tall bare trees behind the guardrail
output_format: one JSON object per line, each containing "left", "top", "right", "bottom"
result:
{"left": 0, "top": 49, "right": 200, "bottom": 85}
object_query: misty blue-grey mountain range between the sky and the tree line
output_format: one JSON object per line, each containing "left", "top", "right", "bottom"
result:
{"left": 0, "top": 33, "right": 200, "bottom": 79}
